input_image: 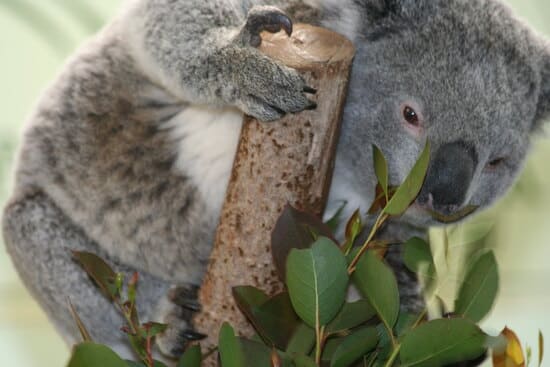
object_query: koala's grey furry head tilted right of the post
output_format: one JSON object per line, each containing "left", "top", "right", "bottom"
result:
{"left": 332, "top": 0, "right": 550, "bottom": 226}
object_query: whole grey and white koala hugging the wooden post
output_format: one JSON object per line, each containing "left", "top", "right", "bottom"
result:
{"left": 3, "top": 0, "right": 550, "bottom": 362}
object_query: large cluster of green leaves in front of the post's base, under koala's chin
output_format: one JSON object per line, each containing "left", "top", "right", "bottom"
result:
{"left": 254, "top": 214, "right": 496, "bottom": 367}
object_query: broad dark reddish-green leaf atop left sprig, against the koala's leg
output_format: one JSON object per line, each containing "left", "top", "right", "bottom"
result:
{"left": 73, "top": 251, "right": 119, "bottom": 300}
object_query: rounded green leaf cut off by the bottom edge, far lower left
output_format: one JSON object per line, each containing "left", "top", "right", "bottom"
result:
{"left": 67, "top": 342, "right": 128, "bottom": 367}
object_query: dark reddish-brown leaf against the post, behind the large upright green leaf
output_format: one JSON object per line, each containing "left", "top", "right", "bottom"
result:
{"left": 271, "top": 205, "right": 332, "bottom": 281}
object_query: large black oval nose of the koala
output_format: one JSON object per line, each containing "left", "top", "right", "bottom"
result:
{"left": 418, "top": 141, "right": 477, "bottom": 214}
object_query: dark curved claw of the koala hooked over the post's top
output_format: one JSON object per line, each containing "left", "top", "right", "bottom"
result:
{"left": 241, "top": 6, "right": 293, "bottom": 47}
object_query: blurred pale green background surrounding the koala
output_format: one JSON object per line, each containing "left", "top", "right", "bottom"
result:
{"left": 0, "top": 0, "right": 550, "bottom": 367}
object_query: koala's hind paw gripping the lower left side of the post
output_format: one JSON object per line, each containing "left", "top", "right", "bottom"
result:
{"left": 156, "top": 286, "right": 205, "bottom": 358}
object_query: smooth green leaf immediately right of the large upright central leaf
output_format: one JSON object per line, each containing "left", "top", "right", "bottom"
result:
{"left": 353, "top": 251, "right": 399, "bottom": 330}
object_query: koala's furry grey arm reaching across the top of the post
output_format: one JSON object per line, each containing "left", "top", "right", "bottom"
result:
{"left": 124, "top": 0, "right": 314, "bottom": 121}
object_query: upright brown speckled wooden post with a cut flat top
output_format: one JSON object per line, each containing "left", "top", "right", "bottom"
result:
{"left": 194, "top": 24, "right": 354, "bottom": 358}
